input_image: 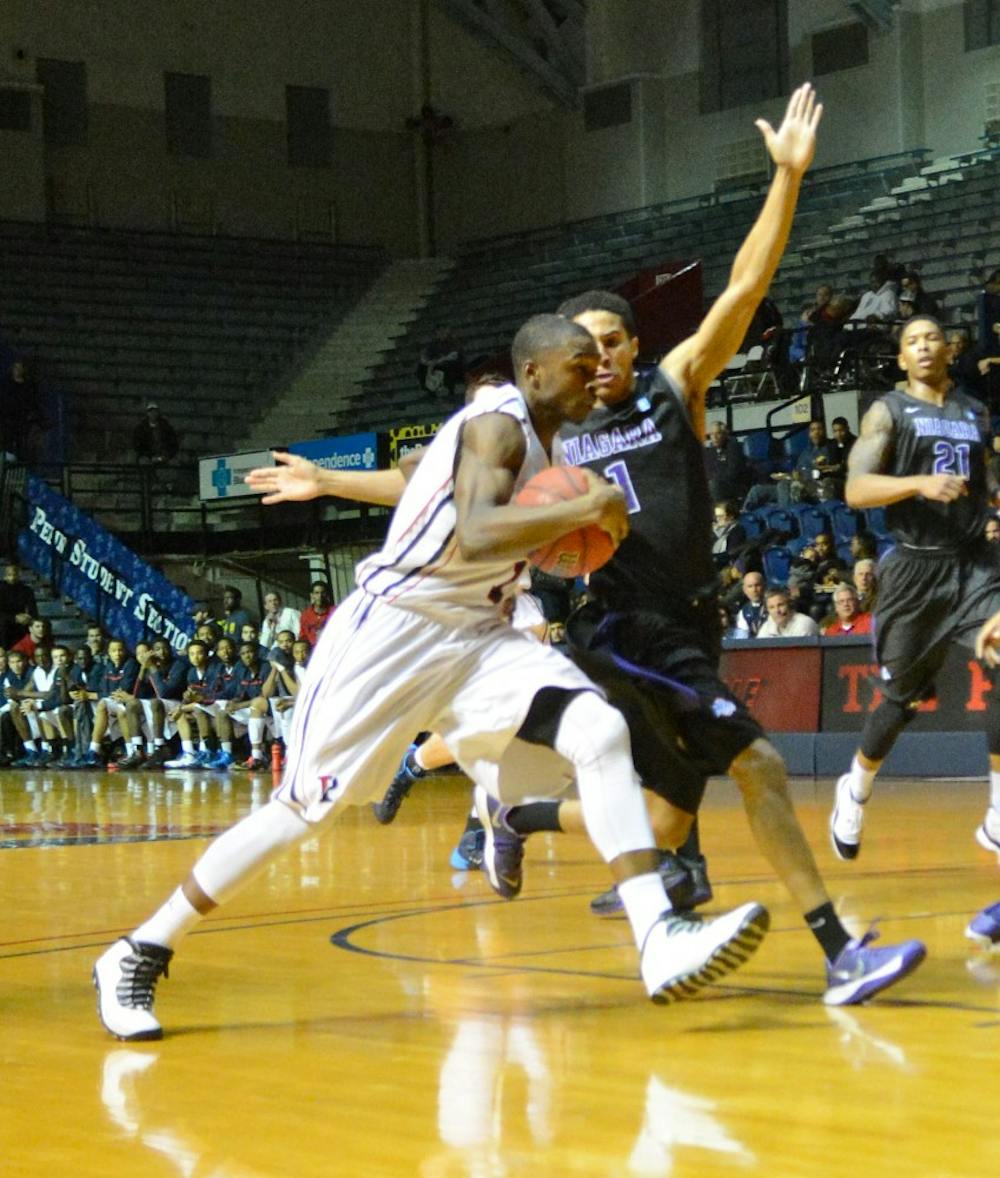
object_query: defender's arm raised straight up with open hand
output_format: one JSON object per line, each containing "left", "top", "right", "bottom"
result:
{"left": 660, "top": 82, "right": 823, "bottom": 437}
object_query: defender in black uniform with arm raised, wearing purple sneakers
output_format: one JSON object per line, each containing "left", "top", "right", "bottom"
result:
{"left": 511, "top": 85, "right": 926, "bottom": 1005}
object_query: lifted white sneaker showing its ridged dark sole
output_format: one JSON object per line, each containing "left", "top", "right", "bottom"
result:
{"left": 641, "top": 904, "right": 770, "bottom": 1002}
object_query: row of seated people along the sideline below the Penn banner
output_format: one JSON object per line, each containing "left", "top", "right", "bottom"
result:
{"left": 0, "top": 582, "right": 335, "bottom": 772}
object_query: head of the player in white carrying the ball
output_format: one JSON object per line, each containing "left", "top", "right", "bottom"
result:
{"left": 510, "top": 315, "right": 598, "bottom": 428}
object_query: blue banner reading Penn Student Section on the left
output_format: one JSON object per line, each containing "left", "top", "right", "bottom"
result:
{"left": 18, "top": 475, "right": 194, "bottom": 651}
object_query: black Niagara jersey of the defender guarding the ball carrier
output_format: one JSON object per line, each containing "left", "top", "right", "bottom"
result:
{"left": 559, "top": 368, "right": 716, "bottom": 615}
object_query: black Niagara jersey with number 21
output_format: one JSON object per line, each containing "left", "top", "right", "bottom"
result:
{"left": 882, "top": 389, "right": 989, "bottom": 550}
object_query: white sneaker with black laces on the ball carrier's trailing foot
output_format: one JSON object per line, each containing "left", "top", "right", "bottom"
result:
{"left": 93, "top": 937, "right": 173, "bottom": 1041}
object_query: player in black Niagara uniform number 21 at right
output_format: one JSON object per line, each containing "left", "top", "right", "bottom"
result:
{"left": 830, "top": 316, "right": 1000, "bottom": 859}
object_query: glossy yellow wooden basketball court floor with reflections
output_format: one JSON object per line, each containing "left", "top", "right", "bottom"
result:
{"left": 0, "top": 772, "right": 1000, "bottom": 1178}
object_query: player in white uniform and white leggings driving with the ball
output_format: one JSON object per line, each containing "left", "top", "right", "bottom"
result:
{"left": 93, "top": 315, "right": 768, "bottom": 1040}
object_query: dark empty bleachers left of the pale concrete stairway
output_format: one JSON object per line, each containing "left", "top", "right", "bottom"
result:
{"left": 0, "top": 221, "right": 385, "bottom": 461}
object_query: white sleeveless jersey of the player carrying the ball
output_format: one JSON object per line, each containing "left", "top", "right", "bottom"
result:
{"left": 356, "top": 384, "right": 550, "bottom": 626}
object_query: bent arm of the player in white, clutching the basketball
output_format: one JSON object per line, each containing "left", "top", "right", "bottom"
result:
{"left": 455, "top": 413, "right": 629, "bottom": 561}
